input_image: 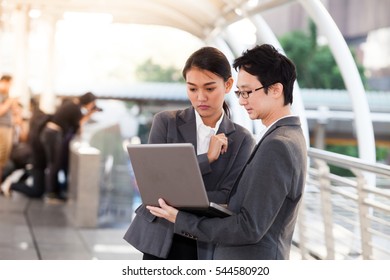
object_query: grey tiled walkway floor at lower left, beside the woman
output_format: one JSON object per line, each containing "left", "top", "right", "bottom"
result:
{"left": 0, "top": 192, "right": 141, "bottom": 260}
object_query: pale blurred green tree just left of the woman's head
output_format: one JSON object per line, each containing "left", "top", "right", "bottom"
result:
{"left": 136, "top": 58, "right": 183, "bottom": 83}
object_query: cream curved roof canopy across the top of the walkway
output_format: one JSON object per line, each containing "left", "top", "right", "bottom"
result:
{"left": 5, "top": 0, "right": 295, "bottom": 39}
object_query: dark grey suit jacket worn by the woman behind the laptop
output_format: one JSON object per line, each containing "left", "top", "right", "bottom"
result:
{"left": 124, "top": 107, "right": 255, "bottom": 258}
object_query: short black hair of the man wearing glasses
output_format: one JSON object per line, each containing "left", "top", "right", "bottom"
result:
{"left": 233, "top": 44, "right": 297, "bottom": 105}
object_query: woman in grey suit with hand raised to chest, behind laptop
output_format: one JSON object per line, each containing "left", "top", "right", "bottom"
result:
{"left": 124, "top": 47, "right": 255, "bottom": 260}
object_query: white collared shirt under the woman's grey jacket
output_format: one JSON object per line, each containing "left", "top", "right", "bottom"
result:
{"left": 195, "top": 110, "right": 224, "bottom": 155}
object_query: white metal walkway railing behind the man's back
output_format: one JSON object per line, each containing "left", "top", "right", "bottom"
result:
{"left": 294, "top": 148, "right": 390, "bottom": 259}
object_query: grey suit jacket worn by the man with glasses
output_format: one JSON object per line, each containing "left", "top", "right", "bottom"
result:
{"left": 174, "top": 117, "right": 307, "bottom": 259}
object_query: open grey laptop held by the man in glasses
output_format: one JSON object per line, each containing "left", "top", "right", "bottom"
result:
{"left": 127, "top": 143, "right": 233, "bottom": 217}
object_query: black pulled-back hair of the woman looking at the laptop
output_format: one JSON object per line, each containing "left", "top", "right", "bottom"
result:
{"left": 182, "top": 47, "right": 232, "bottom": 118}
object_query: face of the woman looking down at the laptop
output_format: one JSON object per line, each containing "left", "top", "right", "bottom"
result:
{"left": 186, "top": 67, "right": 233, "bottom": 127}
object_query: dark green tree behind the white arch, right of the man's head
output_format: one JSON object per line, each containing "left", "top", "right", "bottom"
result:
{"left": 280, "top": 22, "right": 366, "bottom": 89}
